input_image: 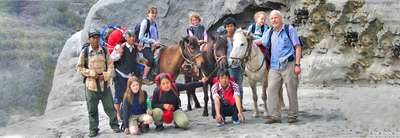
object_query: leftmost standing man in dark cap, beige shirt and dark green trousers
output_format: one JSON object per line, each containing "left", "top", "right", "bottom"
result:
{"left": 76, "top": 31, "right": 121, "bottom": 137}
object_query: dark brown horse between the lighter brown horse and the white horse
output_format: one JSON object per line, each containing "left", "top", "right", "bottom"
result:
{"left": 184, "top": 34, "right": 228, "bottom": 116}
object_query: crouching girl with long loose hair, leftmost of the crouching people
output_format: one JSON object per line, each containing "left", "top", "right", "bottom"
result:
{"left": 123, "top": 76, "right": 153, "bottom": 135}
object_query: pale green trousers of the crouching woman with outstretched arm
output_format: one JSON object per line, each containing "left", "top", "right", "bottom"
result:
{"left": 153, "top": 108, "right": 189, "bottom": 129}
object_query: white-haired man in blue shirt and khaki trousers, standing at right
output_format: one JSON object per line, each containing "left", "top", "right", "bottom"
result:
{"left": 255, "top": 10, "right": 301, "bottom": 124}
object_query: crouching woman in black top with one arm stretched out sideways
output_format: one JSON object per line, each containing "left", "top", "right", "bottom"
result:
{"left": 151, "top": 73, "right": 207, "bottom": 131}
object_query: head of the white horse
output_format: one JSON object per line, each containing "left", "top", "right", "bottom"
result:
{"left": 229, "top": 29, "right": 252, "bottom": 64}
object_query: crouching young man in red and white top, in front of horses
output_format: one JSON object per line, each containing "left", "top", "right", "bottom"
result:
{"left": 211, "top": 69, "right": 244, "bottom": 127}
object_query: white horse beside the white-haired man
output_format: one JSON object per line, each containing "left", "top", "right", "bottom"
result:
{"left": 229, "top": 29, "right": 285, "bottom": 117}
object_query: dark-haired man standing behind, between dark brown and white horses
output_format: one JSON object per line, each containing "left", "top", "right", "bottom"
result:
{"left": 224, "top": 17, "right": 243, "bottom": 109}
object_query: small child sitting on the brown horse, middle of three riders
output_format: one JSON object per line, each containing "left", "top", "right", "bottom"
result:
{"left": 186, "top": 12, "right": 208, "bottom": 51}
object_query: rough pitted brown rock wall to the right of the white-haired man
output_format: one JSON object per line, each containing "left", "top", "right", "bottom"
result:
{"left": 295, "top": 0, "right": 400, "bottom": 84}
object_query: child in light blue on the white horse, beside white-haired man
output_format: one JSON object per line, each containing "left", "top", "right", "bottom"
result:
{"left": 248, "top": 11, "right": 268, "bottom": 39}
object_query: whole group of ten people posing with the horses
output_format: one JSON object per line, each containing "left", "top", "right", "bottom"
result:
{"left": 76, "top": 7, "right": 301, "bottom": 137}
